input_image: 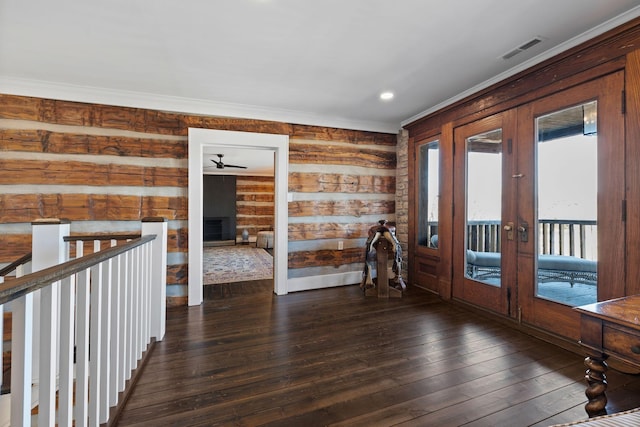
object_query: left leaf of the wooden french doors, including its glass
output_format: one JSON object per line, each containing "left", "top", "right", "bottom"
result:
{"left": 453, "top": 112, "right": 515, "bottom": 314}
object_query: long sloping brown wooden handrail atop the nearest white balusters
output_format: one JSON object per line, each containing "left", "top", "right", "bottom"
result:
{"left": 0, "top": 234, "right": 156, "bottom": 304}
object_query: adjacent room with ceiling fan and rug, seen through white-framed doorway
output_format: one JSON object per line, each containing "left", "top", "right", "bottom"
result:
{"left": 202, "top": 147, "right": 275, "bottom": 299}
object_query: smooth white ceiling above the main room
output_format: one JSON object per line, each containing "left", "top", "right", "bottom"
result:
{"left": 0, "top": 0, "right": 640, "bottom": 176}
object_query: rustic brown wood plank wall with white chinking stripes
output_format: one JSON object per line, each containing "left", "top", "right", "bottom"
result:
{"left": 0, "top": 94, "right": 397, "bottom": 302}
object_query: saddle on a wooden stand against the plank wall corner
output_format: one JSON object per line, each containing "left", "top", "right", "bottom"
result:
{"left": 360, "top": 220, "right": 407, "bottom": 298}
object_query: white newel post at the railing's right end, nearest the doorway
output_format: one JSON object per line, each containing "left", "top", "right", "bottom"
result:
{"left": 142, "top": 217, "right": 167, "bottom": 341}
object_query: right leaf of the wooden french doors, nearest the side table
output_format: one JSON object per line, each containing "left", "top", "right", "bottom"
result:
{"left": 516, "top": 73, "right": 625, "bottom": 339}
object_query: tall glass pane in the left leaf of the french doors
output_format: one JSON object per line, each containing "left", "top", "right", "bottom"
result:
{"left": 465, "top": 129, "right": 502, "bottom": 286}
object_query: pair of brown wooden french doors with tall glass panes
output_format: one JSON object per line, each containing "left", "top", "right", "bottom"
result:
{"left": 453, "top": 73, "right": 625, "bottom": 339}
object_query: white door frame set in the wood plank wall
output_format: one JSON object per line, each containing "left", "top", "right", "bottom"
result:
{"left": 188, "top": 128, "right": 289, "bottom": 305}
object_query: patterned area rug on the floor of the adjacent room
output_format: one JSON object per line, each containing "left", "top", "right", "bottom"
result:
{"left": 202, "top": 245, "right": 273, "bottom": 285}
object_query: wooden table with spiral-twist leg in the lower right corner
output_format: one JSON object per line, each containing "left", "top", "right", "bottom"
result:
{"left": 575, "top": 295, "right": 640, "bottom": 417}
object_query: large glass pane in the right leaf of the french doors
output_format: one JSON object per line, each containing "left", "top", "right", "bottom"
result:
{"left": 536, "top": 101, "right": 598, "bottom": 306}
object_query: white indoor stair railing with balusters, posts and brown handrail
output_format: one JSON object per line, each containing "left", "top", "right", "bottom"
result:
{"left": 0, "top": 219, "right": 167, "bottom": 426}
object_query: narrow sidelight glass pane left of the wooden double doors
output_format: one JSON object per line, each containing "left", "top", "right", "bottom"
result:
{"left": 418, "top": 141, "right": 440, "bottom": 249}
